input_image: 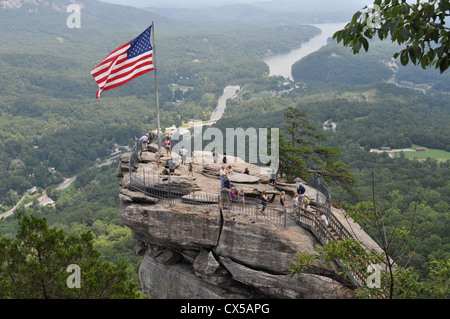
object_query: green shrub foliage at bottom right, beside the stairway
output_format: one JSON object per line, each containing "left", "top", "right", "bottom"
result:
{"left": 289, "top": 239, "right": 450, "bottom": 299}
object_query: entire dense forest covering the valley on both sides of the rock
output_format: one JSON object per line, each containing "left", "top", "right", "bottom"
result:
{"left": 0, "top": 1, "right": 450, "bottom": 298}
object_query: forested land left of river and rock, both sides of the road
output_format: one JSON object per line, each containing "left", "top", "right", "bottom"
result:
{"left": 0, "top": 0, "right": 319, "bottom": 292}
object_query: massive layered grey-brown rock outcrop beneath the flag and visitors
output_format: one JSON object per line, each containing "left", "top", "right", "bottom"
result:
{"left": 119, "top": 146, "right": 366, "bottom": 299}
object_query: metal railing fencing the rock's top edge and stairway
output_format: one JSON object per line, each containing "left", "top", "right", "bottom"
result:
{"left": 129, "top": 141, "right": 366, "bottom": 287}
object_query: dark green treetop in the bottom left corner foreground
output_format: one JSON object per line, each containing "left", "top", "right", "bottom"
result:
{"left": 0, "top": 214, "right": 143, "bottom": 299}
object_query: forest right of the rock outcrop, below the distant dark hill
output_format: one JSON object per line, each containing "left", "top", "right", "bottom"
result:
{"left": 217, "top": 75, "right": 450, "bottom": 276}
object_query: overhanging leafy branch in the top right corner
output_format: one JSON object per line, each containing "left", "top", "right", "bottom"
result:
{"left": 333, "top": 0, "right": 450, "bottom": 73}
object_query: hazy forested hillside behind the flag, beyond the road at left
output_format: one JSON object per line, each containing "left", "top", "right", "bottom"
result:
{"left": 0, "top": 1, "right": 318, "bottom": 194}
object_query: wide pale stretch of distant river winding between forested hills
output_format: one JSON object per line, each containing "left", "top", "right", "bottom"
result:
{"left": 263, "top": 22, "right": 347, "bottom": 81}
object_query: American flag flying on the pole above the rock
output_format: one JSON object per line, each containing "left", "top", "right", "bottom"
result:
{"left": 91, "top": 26, "right": 153, "bottom": 99}
